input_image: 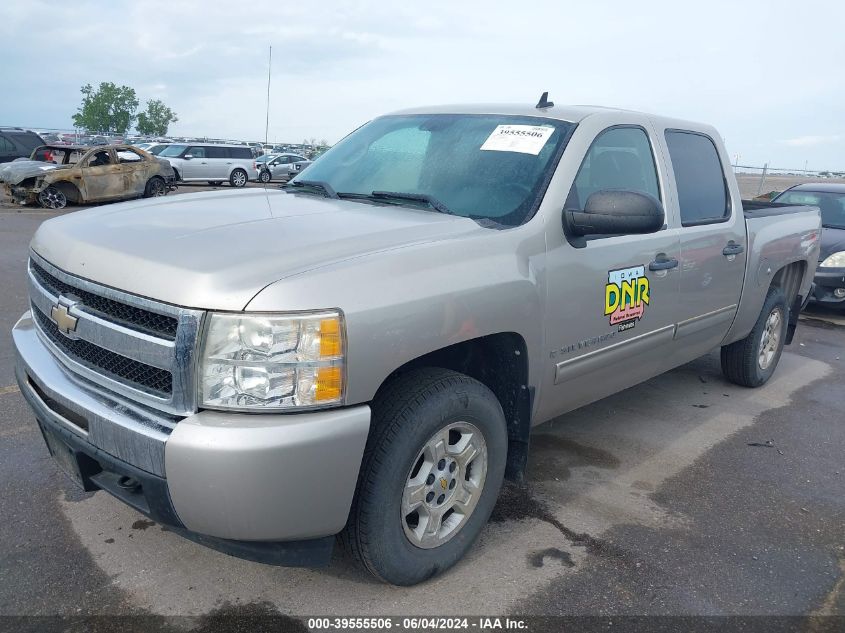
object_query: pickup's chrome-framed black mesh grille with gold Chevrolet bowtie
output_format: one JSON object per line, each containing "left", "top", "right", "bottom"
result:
{"left": 29, "top": 253, "right": 203, "bottom": 415}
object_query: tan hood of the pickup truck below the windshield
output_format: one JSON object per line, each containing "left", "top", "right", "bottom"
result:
{"left": 32, "top": 189, "right": 482, "bottom": 310}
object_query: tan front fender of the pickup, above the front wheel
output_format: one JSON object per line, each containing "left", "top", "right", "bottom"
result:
{"left": 246, "top": 226, "right": 545, "bottom": 405}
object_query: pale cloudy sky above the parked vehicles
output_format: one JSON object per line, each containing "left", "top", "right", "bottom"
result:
{"left": 0, "top": 0, "right": 845, "bottom": 170}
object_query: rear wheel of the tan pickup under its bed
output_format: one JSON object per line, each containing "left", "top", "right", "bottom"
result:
{"left": 722, "top": 287, "right": 789, "bottom": 387}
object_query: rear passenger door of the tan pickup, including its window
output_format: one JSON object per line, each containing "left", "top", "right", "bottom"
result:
{"left": 663, "top": 129, "right": 747, "bottom": 358}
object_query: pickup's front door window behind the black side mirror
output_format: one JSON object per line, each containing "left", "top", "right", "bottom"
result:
{"left": 566, "top": 127, "right": 660, "bottom": 209}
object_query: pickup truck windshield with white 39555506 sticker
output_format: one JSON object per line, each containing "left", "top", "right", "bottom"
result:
{"left": 292, "top": 114, "right": 573, "bottom": 226}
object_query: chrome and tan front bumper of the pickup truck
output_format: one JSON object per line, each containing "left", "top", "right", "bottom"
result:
{"left": 12, "top": 312, "right": 370, "bottom": 564}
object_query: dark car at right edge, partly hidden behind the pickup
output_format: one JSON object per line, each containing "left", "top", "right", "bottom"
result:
{"left": 774, "top": 183, "right": 845, "bottom": 307}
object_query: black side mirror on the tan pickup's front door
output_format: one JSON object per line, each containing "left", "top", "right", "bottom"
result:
{"left": 563, "top": 189, "right": 666, "bottom": 237}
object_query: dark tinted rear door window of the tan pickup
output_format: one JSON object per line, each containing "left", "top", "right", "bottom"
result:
{"left": 666, "top": 130, "right": 731, "bottom": 226}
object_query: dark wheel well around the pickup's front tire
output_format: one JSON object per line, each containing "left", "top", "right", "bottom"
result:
{"left": 370, "top": 332, "right": 534, "bottom": 481}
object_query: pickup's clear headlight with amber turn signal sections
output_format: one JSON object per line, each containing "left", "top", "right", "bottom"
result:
{"left": 200, "top": 312, "right": 345, "bottom": 411}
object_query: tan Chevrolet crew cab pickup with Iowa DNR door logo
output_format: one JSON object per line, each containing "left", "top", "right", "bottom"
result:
{"left": 13, "top": 99, "right": 821, "bottom": 585}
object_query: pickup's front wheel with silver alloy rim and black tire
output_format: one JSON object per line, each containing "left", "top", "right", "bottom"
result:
{"left": 341, "top": 368, "right": 507, "bottom": 585}
